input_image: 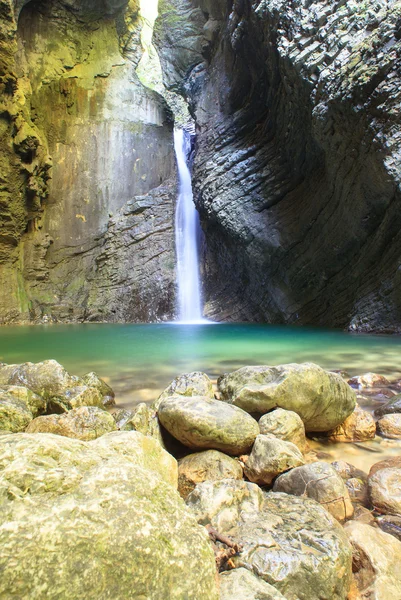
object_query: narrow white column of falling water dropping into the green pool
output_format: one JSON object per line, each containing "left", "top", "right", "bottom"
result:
{"left": 174, "top": 129, "right": 202, "bottom": 322}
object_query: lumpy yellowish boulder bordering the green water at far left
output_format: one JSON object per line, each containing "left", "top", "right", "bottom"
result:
{"left": 0, "top": 360, "right": 113, "bottom": 412}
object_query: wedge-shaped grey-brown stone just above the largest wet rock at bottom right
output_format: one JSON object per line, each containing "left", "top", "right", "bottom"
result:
{"left": 273, "top": 462, "right": 354, "bottom": 523}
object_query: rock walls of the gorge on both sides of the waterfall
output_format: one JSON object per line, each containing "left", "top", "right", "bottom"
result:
{"left": 0, "top": 0, "right": 401, "bottom": 332}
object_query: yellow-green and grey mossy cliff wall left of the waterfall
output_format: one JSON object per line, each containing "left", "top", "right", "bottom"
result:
{"left": 0, "top": 0, "right": 176, "bottom": 322}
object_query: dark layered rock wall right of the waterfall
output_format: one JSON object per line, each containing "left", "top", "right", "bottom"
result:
{"left": 156, "top": 0, "right": 401, "bottom": 331}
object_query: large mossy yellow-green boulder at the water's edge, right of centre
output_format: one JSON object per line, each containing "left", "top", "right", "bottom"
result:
{"left": 218, "top": 363, "right": 356, "bottom": 431}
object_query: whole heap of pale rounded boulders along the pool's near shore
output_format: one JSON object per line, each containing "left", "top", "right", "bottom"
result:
{"left": 0, "top": 360, "right": 401, "bottom": 600}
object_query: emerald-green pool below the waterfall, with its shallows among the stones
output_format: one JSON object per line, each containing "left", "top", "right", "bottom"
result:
{"left": 0, "top": 324, "right": 401, "bottom": 470}
